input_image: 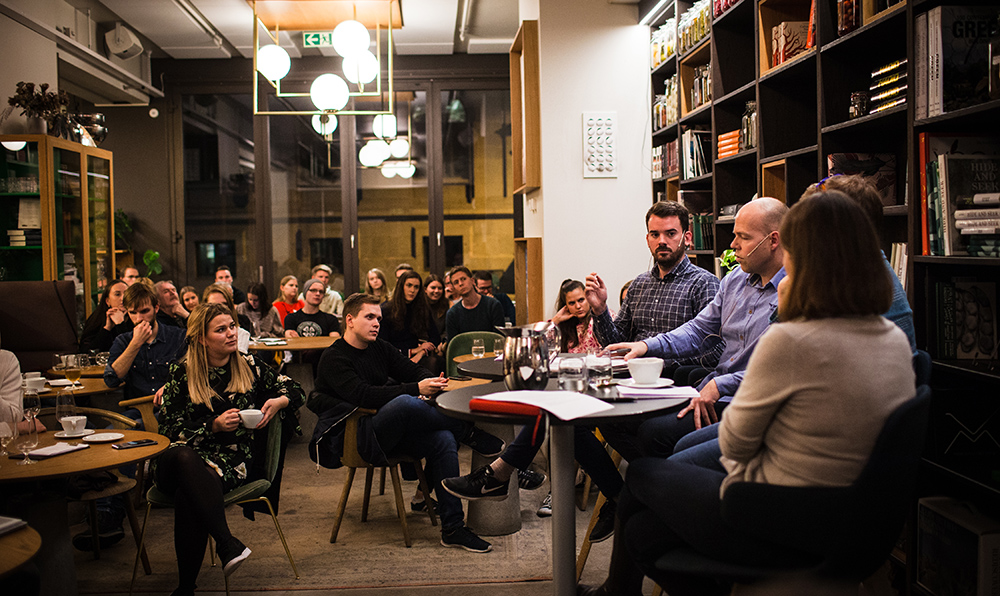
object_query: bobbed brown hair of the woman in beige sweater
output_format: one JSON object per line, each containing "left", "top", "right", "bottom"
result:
{"left": 780, "top": 190, "right": 892, "bottom": 320}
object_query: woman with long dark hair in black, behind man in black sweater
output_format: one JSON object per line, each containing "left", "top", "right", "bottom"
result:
{"left": 379, "top": 269, "right": 443, "bottom": 373}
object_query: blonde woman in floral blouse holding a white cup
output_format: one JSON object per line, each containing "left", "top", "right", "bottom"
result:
{"left": 153, "top": 304, "right": 303, "bottom": 595}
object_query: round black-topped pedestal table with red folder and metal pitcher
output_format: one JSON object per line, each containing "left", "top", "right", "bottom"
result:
{"left": 435, "top": 379, "right": 688, "bottom": 596}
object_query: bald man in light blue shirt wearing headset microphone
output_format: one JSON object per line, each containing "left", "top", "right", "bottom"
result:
{"left": 602, "top": 198, "right": 788, "bottom": 461}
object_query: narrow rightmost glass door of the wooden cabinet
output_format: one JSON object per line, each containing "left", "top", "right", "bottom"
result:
{"left": 86, "top": 155, "right": 114, "bottom": 306}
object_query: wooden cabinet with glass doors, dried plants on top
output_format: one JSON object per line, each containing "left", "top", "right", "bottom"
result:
{"left": 0, "top": 135, "right": 115, "bottom": 320}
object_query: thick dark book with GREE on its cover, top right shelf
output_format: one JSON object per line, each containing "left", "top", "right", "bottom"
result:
{"left": 914, "top": 5, "right": 1000, "bottom": 118}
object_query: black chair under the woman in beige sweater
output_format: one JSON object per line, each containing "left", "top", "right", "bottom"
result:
{"left": 640, "top": 385, "right": 931, "bottom": 585}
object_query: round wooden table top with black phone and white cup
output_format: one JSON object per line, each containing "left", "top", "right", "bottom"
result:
{"left": 0, "top": 430, "right": 170, "bottom": 483}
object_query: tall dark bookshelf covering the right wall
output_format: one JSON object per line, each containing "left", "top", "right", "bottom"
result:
{"left": 640, "top": 0, "right": 1000, "bottom": 594}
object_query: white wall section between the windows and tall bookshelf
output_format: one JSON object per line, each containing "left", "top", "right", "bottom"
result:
{"left": 522, "top": 0, "right": 652, "bottom": 315}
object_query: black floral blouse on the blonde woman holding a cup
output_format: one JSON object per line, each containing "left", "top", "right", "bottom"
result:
{"left": 160, "top": 353, "right": 304, "bottom": 491}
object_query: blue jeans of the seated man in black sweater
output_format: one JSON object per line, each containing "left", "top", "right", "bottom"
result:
{"left": 372, "top": 395, "right": 470, "bottom": 531}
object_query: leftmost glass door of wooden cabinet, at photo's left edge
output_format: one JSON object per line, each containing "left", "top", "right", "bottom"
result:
{"left": 0, "top": 141, "right": 45, "bottom": 281}
